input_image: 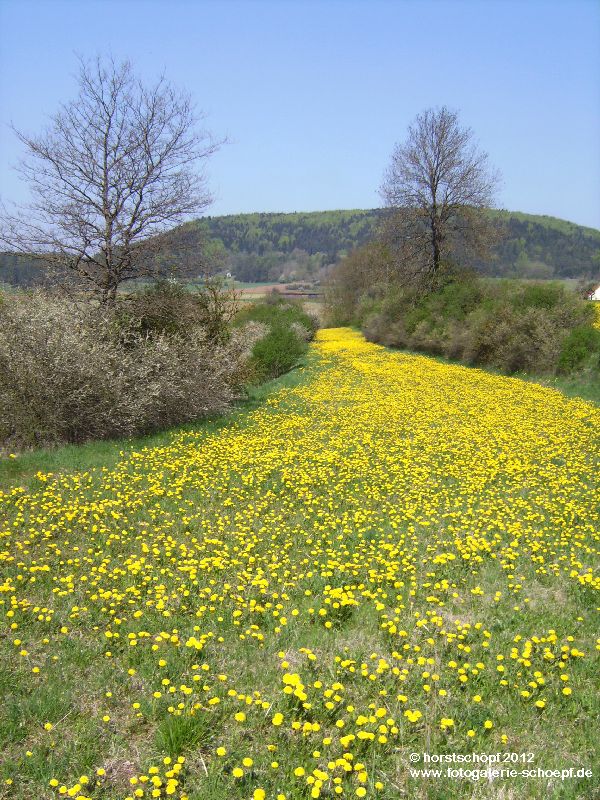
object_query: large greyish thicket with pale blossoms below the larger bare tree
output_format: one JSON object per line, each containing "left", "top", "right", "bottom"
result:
{"left": 0, "top": 289, "right": 260, "bottom": 447}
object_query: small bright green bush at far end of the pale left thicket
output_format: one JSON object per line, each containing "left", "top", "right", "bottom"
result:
{"left": 235, "top": 292, "right": 318, "bottom": 382}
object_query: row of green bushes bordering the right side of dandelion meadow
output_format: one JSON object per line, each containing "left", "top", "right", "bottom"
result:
{"left": 359, "top": 276, "right": 600, "bottom": 375}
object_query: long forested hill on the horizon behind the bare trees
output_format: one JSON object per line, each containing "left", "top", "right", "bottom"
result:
{"left": 0, "top": 209, "right": 600, "bottom": 286}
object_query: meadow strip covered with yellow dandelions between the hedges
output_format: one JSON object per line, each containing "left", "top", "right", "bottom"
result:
{"left": 0, "top": 329, "right": 600, "bottom": 800}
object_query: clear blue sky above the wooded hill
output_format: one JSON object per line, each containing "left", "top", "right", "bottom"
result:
{"left": 0, "top": 0, "right": 600, "bottom": 227}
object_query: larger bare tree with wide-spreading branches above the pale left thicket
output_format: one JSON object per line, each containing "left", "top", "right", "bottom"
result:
{"left": 0, "top": 58, "right": 220, "bottom": 303}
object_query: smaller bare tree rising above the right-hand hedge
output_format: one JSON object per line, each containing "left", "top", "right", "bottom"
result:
{"left": 381, "top": 106, "right": 499, "bottom": 286}
